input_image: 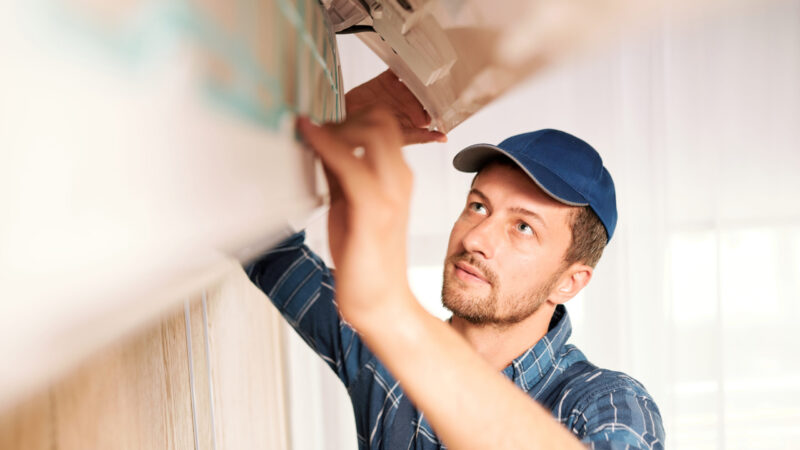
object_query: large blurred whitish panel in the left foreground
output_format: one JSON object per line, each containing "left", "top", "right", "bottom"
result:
{"left": 0, "top": 0, "right": 343, "bottom": 409}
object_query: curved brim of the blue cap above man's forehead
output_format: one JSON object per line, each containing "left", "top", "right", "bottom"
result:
{"left": 453, "top": 144, "right": 589, "bottom": 206}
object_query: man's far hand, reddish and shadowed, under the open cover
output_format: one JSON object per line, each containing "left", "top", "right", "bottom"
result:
{"left": 345, "top": 70, "right": 447, "bottom": 145}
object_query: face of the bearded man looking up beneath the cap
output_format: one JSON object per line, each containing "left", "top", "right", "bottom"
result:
{"left": 442, "top": 164, "right": 574, "bottom": 325}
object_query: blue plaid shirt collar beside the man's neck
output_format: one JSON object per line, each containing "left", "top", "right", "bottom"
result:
{"left": 503, "top": 305, "right": 572, "bottom": 392}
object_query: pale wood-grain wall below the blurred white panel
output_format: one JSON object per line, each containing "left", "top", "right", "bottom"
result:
{"left": 0, "top": 268, "right": 289, "bottom": 450}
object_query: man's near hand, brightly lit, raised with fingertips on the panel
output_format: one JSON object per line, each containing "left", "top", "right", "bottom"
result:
{"left": 298, "top": 109, "right": 412, "bottom": 329}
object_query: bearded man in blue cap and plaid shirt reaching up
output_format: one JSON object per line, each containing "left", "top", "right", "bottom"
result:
{"left": 247, "top": 72, "right": 664, "bottom": 449}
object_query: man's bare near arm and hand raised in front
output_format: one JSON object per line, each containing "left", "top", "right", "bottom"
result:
{"left": 298, "top": 110, "right": 583, "bottom": 449}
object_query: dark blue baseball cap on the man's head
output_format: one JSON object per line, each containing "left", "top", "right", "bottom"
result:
{"left": 453, "top": 129, "right": 617, "bottom": 241}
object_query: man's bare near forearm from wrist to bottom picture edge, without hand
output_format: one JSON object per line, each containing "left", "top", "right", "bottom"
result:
{"left": 353, "top": 293, "right": 584, "bottom": 449}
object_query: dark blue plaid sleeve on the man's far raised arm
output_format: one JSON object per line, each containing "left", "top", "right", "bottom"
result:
{"left": 245, "top": 231, "right": 372, "bottom": 388}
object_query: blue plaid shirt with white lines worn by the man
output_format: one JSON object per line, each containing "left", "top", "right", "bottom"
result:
{"left": 246, "top": 232, "right": 664, "bottom": 449}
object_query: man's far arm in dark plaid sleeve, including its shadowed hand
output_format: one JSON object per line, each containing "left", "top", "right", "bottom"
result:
{"left": 245, "top": 70, "right": 447, "bottom": 386}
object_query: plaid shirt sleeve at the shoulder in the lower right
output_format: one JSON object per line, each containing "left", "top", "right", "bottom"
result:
{"left": 580, "top": 387, "right": 664, "bottom": 450}
